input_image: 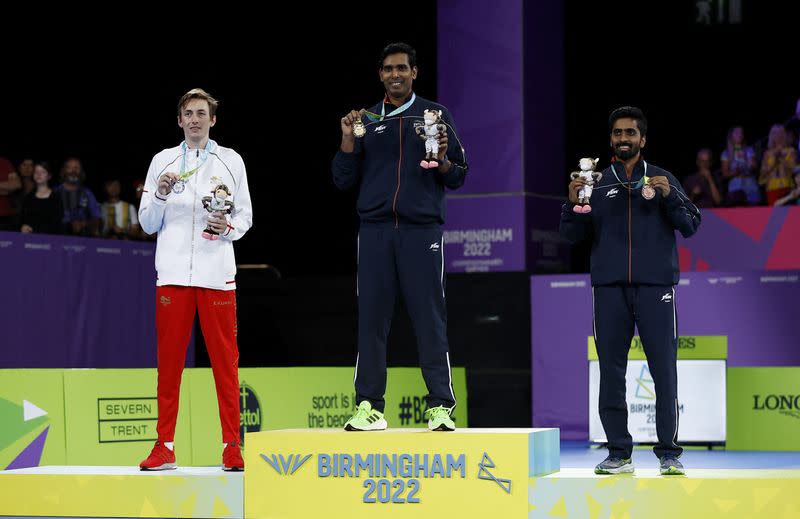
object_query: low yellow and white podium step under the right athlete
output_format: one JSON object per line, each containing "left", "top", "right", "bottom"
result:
{"left": 528, "top": 467, "right": 800, "bottom": 519}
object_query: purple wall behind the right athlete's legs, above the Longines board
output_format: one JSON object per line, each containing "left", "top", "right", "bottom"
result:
{"left": 531, "top": 270, "right": 800, "bottom": 440}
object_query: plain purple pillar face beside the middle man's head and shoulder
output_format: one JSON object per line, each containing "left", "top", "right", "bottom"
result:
{"left": 437, "top": 0, "right": 524, "bottom": 194}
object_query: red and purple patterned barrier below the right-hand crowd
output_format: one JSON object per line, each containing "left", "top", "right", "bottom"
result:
{"left": 678, "top": 206, "right": 800, "bottom": 272}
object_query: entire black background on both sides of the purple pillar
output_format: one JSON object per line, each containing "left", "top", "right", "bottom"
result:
{"left": 0, "top": 0, "right": 800, "bottom": 276}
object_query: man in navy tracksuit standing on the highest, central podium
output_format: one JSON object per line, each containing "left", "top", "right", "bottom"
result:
{"left": 332, "top": 44, "right": 467, "bottom": 430}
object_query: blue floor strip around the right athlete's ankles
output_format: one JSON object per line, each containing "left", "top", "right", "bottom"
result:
{"left": 561, "top": 441, "right": 800, "bottom": 470}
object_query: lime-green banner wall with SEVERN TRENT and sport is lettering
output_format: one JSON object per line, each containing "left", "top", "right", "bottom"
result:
{"left": 0, "top": 368, "right": 468, "bottom": 469}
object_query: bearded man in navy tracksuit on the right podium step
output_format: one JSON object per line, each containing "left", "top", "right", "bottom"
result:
{"left": 561, "top": 107, "right": 700, "bottom": 474}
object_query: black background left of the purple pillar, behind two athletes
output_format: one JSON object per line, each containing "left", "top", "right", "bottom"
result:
{"left": 0, "top": 6, "right": 437, "bottom": 276}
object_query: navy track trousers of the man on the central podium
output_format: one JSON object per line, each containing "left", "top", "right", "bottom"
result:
{"left": 355, "top": 223, "right": 456, "bottom": 412}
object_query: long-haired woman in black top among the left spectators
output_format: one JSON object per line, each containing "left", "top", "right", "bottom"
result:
{"left": 20, "top": 162, "right": 64, "bottom": 234}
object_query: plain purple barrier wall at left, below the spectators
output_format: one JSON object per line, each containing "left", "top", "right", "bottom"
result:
{"left": 0, "top": 232, "right": 194, "bottom": 368}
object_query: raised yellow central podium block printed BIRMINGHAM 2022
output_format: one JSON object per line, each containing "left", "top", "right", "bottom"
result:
{"left": 245, "top": 429, "right": 559, "bottom": 518}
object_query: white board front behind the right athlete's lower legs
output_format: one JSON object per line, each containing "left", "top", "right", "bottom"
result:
{"left": 589, "top": 360, "right": 726, "bottom": 443}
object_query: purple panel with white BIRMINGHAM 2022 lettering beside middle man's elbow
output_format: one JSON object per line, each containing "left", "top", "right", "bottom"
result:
{"left": 443, "top": 195, "right": 525, "bottom": 272}
